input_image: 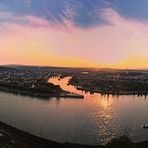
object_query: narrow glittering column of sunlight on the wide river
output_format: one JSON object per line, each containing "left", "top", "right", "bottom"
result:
{"left": 93, "top": 94, "right": 118, "bottom": 142}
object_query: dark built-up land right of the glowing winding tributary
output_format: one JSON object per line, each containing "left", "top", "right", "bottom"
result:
{"left": 69, "top": 71, "right": 148, "bottom": 94}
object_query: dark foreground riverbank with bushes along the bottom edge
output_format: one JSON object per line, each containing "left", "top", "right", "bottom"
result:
{"left": 0, "top": 121, "right": 148, "bottom": 148}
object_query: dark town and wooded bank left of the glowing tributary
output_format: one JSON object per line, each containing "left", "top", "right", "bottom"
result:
{"left": 0, "top": 68, "right": 62, "bottom": 98}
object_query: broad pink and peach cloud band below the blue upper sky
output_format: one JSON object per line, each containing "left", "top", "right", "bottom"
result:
{"left": 0, "top": 8, "right": 148, "bottom": 66}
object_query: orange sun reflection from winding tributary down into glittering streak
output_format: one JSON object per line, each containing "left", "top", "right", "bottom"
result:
{"left": 49, "top": 77, "right": 118, "bottom": 142}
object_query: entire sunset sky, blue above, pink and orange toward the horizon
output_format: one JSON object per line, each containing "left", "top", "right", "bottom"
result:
{"left": 0, "top": 0, "right": 148, "bottom": 68}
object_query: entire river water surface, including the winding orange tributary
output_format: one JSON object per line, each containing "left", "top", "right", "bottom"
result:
{"left": 0, "top": 77, "right": 148, "bottom": 144}
